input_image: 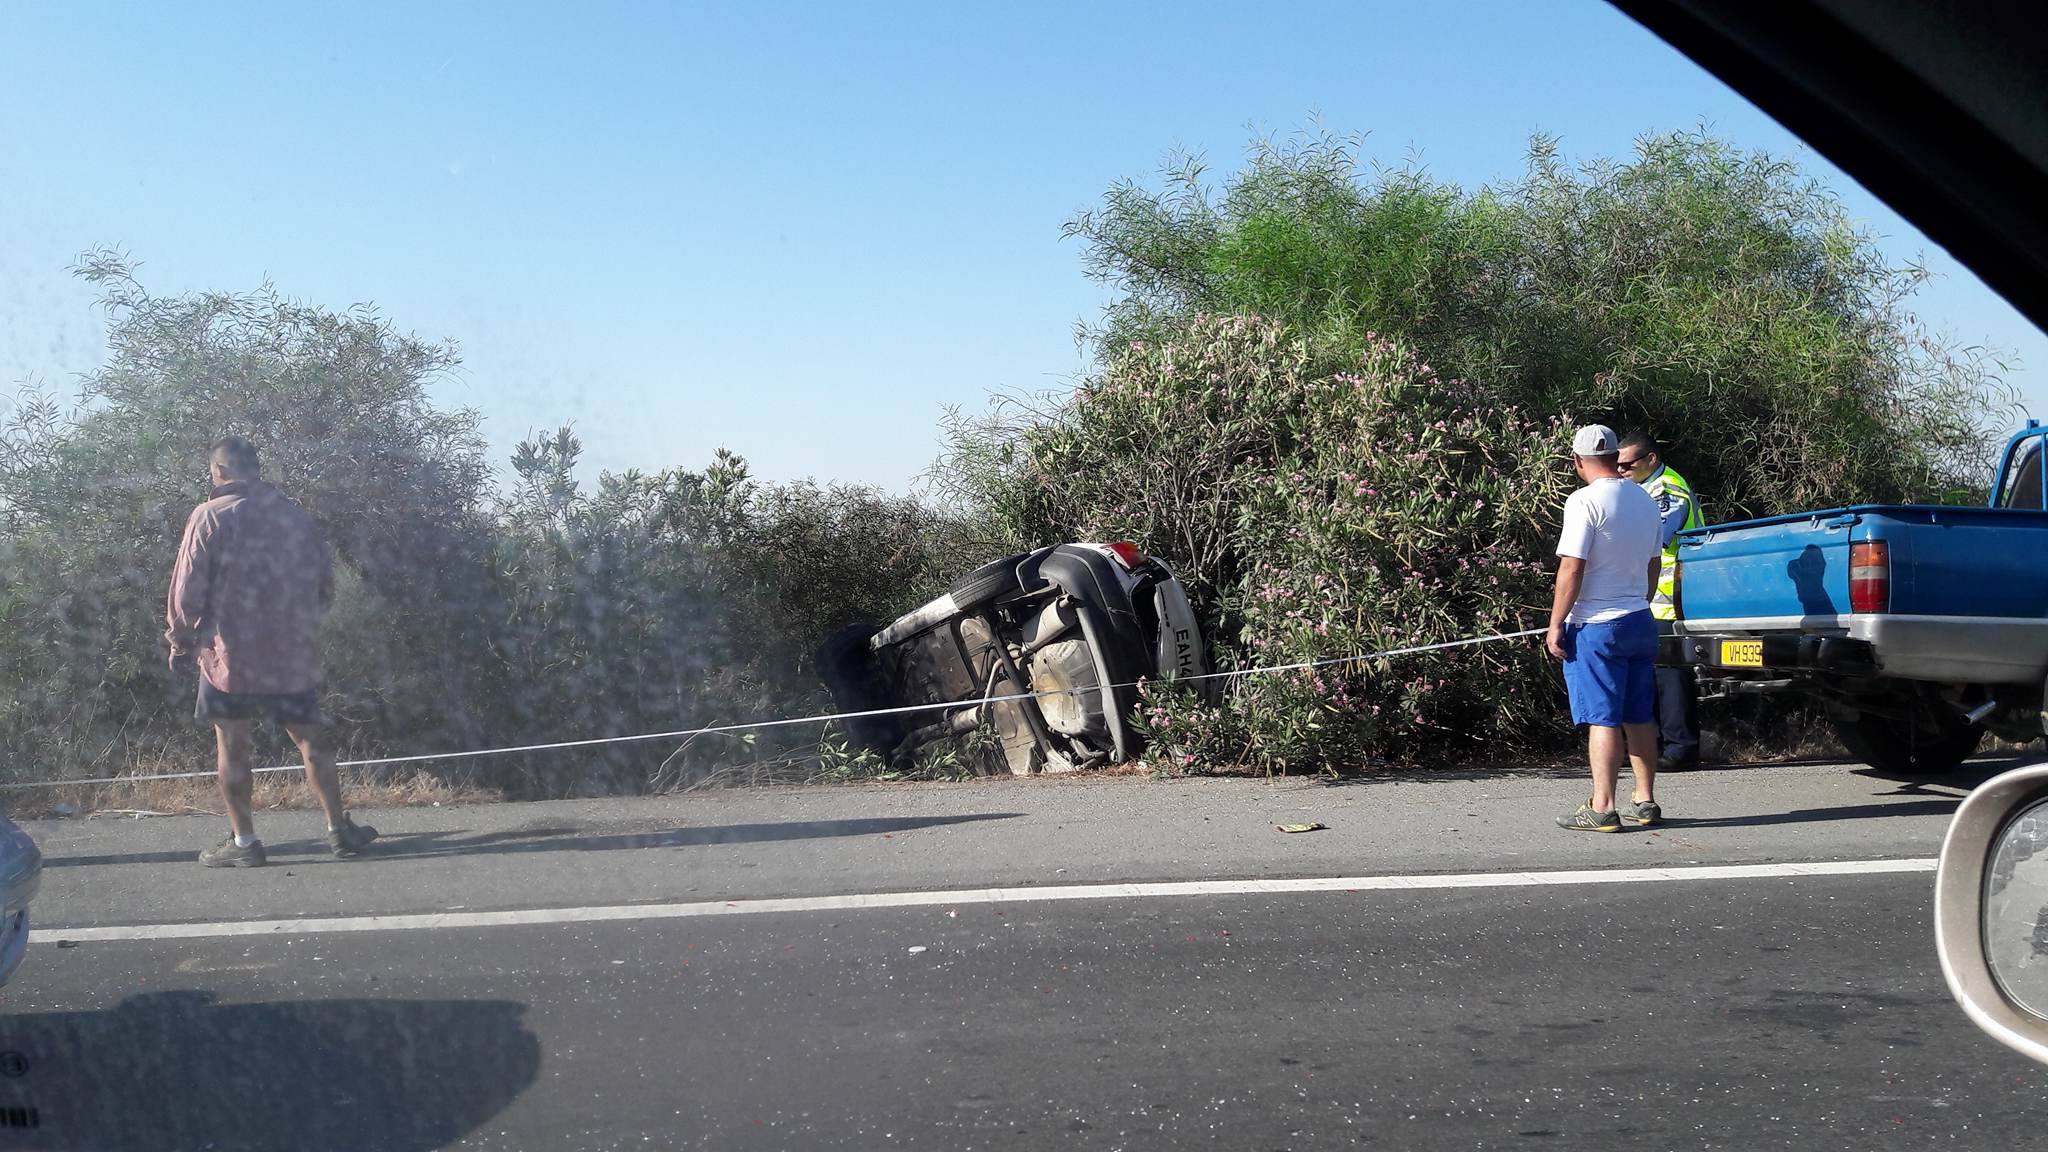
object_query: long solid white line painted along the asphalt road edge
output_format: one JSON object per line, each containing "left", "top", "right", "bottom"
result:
{"left": 29, "top": 859, "right": 1933, "bottom": 945}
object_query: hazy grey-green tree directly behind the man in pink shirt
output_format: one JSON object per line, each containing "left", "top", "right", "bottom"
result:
{"left": 0, "top": 252, "right": 487, "bottom": 771}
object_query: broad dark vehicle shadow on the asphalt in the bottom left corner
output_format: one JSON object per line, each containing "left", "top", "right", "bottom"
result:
{"left": 0, "top": 992, "right": 541, "bottom": 1152}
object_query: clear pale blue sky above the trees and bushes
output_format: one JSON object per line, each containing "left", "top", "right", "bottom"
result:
{"left": 0, "top": 0, "right": 2048, "bottom": 490}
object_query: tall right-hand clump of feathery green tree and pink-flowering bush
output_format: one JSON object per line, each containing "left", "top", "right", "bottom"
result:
{"left": 934, "top": 125, "right": 2009, "bottom": 771}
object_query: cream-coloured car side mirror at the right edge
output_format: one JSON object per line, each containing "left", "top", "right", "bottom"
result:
{"left": 1933, "top": 763, "right": 2048, "bottom": 1064}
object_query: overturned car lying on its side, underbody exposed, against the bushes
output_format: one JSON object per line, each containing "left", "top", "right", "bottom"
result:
{"left": 817, "top": 543, "right": 1217, "bottom": 775}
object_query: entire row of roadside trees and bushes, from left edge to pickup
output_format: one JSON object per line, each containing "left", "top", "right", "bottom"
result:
{"left": 0, "top": 133, "right": 2007, "bottom": 795}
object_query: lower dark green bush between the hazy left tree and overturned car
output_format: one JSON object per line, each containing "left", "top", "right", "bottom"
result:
{"left": 489, "top": 428, "right": 952, "bottom": 795}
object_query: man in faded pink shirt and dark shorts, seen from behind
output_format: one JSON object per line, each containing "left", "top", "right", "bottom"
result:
{"left": 166, "top": 437, "right": 377, "bottom": 867}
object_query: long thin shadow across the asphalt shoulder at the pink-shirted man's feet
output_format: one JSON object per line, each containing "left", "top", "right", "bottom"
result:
{"left": 43, "top": 812, "right": 1022, "bottom": 867}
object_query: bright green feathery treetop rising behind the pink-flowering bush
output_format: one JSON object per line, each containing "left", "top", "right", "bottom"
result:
{"left": 1067, "top": 133, "right": 2011, "bottom": 519}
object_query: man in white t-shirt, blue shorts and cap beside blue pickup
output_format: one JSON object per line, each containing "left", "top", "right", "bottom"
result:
{"left": 1544, "top": 424, "right": 1663, "bottom": 832}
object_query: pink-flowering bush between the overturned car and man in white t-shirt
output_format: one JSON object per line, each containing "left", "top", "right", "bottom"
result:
{"left": 1026, "top": 316, "right": 1565, "bottom": 771}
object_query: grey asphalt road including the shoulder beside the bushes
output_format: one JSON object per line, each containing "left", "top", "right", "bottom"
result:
{"left": 0, "top": 750, "right": 2048, "bottom": 1150}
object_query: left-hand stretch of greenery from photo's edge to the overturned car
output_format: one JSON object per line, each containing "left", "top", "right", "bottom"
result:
{"left": 0, "top": 254, "right": 958, "bottom": 797}
